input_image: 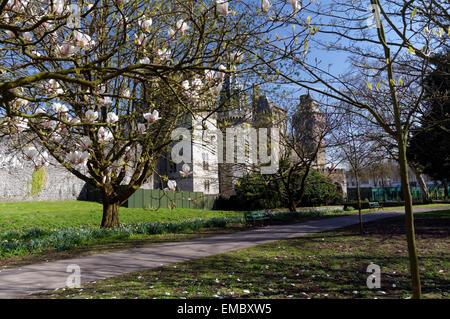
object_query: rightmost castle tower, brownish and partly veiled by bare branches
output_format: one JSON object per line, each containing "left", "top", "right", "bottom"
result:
{"left": 292, "top": 92, "right": 326, "bottom": 169}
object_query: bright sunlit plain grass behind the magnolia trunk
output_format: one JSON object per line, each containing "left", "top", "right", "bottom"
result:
{"left": 0, "top": 201, "right": 242, "bottom": 234}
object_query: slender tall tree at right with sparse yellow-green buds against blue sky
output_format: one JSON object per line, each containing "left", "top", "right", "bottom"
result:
{"left": 251, "top": 0, "right": 448, "bottom": 298}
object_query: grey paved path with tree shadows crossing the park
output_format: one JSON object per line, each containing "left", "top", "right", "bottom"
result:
{"left": 0, "top": 207, "right": 450, "bottom": 298}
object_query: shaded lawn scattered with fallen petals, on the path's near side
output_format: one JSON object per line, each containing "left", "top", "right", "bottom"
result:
{"left": 29, "top": 210, "right": 450, "bottom": 298}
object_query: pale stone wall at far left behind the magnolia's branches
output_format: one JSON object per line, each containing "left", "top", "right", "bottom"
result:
{"left": 0, "top": 144, "right": 86, "bottom": 201}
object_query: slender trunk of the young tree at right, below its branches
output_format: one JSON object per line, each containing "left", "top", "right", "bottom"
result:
{"left": 398, "top": 138, "right": 422, "bottom": 299}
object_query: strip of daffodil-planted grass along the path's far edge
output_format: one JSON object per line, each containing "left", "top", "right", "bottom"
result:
{"left": 0, "top": 206, "right": 345, "bottom": 267}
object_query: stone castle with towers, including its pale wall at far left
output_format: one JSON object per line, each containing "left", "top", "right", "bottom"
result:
{"left": 0, "top": 77, "right": 347, "bottom": 201}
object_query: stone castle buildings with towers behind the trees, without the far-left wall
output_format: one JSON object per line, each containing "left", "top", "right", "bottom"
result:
{"left": 149, "top": 77, "right": 347, "bottom": 196}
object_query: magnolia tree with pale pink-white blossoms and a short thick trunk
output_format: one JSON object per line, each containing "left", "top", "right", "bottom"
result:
{"left": 0, "top": 0, "right": 310, "bottom": 227}
